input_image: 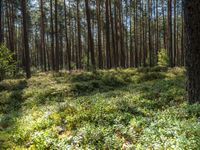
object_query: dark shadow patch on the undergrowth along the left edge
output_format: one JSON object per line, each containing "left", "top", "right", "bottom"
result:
{"left": 0, "top": 80, "right": 27, "bottom": 145}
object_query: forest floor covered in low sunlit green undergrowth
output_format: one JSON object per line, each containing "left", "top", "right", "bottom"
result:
{"left": 0, "top": 67, "right": 200, "bottom": 150}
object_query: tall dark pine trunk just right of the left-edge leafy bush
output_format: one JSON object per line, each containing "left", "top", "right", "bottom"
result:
{"left": 21, "top": 0, "right": 31, "bottom": 79}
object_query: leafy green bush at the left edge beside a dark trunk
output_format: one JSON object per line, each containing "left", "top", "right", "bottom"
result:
{"left": 0, "top": 44, "right": 15, "bottom": 81}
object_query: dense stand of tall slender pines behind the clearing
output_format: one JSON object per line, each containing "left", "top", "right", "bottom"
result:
{"left": 0, "top": 0, "right": 185, "bottom": 78}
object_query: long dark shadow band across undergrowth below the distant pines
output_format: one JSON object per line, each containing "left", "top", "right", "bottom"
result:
{"left": 51, "top": 67, "right": 167, "bottom": 96}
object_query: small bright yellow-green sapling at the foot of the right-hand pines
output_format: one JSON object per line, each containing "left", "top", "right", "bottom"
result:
{"left": 158, "top": 49, "right": 169, "bottom": 67}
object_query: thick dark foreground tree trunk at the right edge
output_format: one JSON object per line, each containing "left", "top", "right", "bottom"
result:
{"left": 184, "top": 0, "right": 200, "bottom": 103}
